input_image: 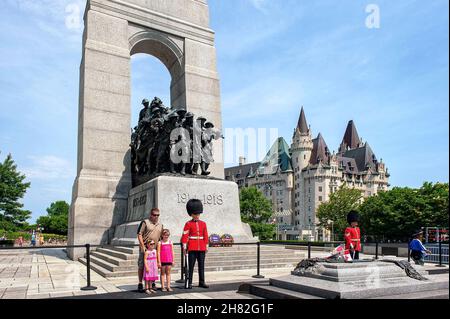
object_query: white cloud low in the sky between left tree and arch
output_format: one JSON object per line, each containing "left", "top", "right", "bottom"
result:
{"left": 23, "top": 155, "right": 75, "bottom": 180}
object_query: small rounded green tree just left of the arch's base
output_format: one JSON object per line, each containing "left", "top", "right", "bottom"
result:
{"left": 36, "top": 201, "right": 69, "bottom": 235}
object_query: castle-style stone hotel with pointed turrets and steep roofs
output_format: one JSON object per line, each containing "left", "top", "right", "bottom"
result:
{"left": 225, "top": 107, "right": 389, "bottom": 241}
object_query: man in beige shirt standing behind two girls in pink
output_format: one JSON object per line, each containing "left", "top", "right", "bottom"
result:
{"left": 137, "top": 208, "right": 164, "bottom": 292}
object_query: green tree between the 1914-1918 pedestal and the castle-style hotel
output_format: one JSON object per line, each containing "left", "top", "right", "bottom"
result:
{"left": 239, "top": 187, "right": 275, "bottom": 240}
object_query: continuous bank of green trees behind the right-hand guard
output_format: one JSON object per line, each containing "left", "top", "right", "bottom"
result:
{"left": 317, "top": 182, "right": 449, "bottom": 241}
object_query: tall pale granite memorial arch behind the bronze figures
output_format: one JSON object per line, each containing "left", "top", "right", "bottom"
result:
{"left": 69, "top": 0, "right": 224, "bottom": 259}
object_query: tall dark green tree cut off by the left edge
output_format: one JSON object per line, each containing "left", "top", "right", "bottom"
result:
{"left": 0, "top": 154, "right": 31, "bottom": 230}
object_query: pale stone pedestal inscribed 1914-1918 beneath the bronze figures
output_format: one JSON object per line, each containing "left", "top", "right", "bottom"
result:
{"left": 112, "top": 176, "right": 256, "bottom": 245}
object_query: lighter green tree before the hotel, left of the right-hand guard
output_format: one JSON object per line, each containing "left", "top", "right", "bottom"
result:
{"left": 317, "top": 185, "right": 362, "bottom": 239}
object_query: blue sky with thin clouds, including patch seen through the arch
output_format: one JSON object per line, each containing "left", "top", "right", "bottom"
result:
{"left": 0, "top": 0, "right": 449, "bottom": 221}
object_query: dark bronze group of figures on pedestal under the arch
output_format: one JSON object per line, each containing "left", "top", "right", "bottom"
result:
{"left": 130, "top": 97, "right": 223, "bottom": 184}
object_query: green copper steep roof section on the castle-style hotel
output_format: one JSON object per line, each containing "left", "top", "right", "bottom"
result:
{"left": 258, "top": 137, "right": 292, "bottom": 174}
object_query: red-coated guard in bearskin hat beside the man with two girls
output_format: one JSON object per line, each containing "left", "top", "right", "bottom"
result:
{"left": 181, "top": 199, "right": 209, "bottom": 289}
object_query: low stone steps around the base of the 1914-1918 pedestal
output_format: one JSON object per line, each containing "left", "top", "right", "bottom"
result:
{"left": 79, "top": 245, "right": 305, "bottom": 278}
